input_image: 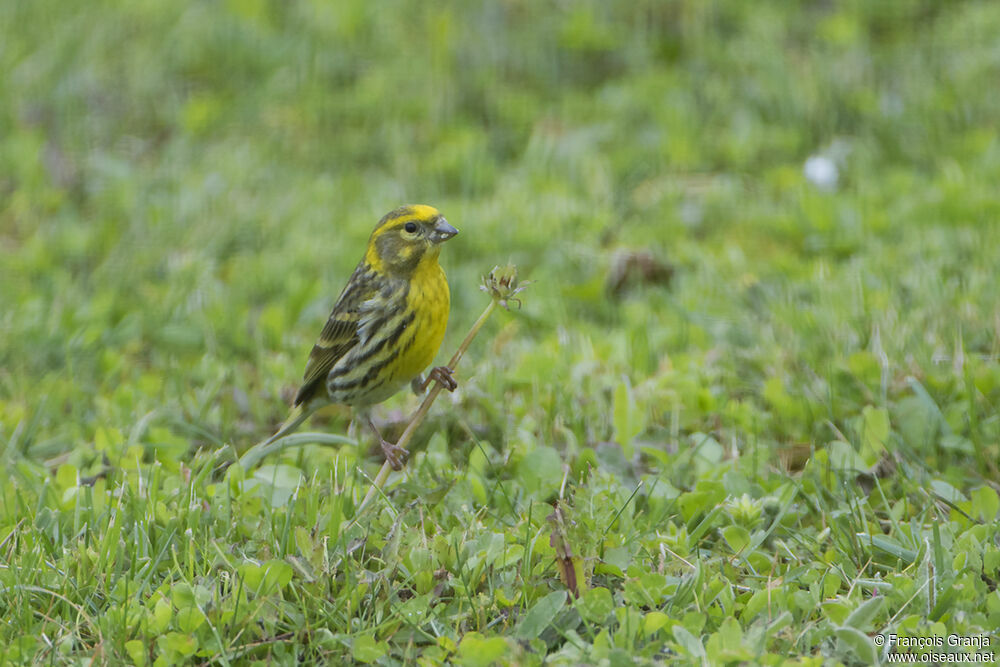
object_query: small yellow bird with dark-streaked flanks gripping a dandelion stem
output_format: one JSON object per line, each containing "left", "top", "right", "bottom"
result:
{"left": 265, "top": 205, "right": 458, "bottom": 470}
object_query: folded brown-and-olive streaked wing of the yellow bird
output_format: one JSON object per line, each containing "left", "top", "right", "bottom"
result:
{"left": 295, "top": 267, "right": 375, "bottom": 405}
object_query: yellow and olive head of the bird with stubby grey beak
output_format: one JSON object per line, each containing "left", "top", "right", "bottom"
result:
{"left": 365, "top": 204, "right": 458, "bottom": 276}
